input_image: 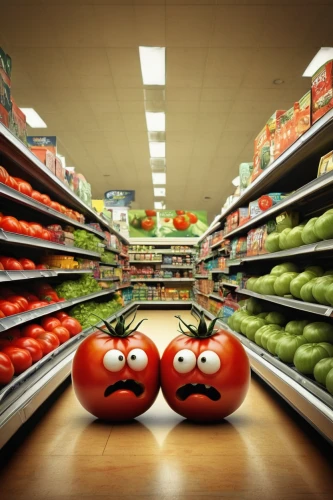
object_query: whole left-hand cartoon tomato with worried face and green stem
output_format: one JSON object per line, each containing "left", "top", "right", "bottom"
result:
{"left": 72, "top": 316, "right": 160, "bottom": 422}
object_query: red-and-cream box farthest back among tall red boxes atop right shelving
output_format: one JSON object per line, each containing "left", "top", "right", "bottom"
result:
{"left": 251, "top": 110, "right": 285, "bottom": 182}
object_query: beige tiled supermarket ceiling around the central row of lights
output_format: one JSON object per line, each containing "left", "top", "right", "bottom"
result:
{"left": 0, "top": 0, "right": 333, "bottom": 221}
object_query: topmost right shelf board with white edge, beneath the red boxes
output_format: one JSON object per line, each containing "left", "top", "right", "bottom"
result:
{"left": 212, "top": 110, "right": 333, "bottom": 229}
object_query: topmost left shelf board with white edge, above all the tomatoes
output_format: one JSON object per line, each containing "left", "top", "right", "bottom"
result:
{"left": 0, "top": 123, "right": 129, "bottom": 244}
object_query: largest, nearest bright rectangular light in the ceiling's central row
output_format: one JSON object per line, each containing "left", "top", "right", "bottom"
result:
{"left": 139, "top": 47, "right": 165, "bottom": 85}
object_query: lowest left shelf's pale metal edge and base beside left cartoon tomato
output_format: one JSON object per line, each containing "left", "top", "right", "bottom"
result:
{"left": 0, "top": 302, "right": 135, "bottom": 448}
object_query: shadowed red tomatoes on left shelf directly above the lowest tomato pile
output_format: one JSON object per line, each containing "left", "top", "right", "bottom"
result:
{"left": 0, "top": 283, "right": 64, "bottom": 320}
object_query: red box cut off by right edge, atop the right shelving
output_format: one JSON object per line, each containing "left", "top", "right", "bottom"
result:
{"left": 311, "top": 61, "right": 333, "bottom": 123}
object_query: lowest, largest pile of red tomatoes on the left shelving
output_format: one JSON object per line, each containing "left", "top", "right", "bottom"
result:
{"left": 0, "top": 311, "right": 82, "bottom": 386}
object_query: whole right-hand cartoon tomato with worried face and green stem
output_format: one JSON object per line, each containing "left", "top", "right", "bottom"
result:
{"left": 161, "top": 313, "right": 250, "bottom": 422}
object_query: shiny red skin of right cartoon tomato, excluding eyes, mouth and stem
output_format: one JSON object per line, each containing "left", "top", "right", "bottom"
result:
{"left": 161, "top": 330, "right": 251, "bottom": 422}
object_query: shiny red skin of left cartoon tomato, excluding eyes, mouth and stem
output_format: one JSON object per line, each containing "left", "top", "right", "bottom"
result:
{"left": 72, "top": 331, "right": 160, "bottom": 422}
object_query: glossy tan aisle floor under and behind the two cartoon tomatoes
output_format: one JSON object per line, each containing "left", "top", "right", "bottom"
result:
{"left": 0, "top": 311, "right": 333, "bottom": 500}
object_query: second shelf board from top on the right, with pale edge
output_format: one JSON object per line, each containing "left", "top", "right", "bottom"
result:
{"left": 225, "top": 172, "right": 333, "bottom": 239}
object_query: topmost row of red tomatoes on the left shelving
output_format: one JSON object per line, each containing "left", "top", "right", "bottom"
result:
{"left": 0, "top": 166, "right": 84, "bottom": 223}
